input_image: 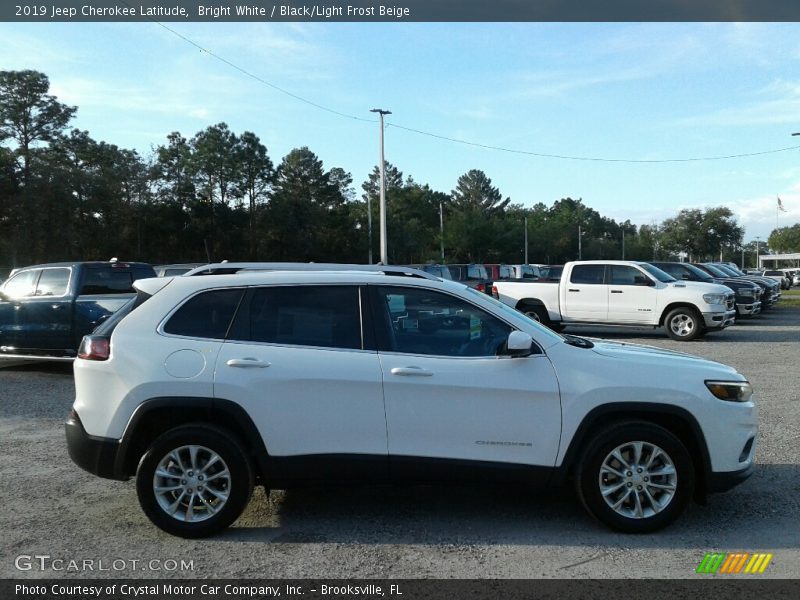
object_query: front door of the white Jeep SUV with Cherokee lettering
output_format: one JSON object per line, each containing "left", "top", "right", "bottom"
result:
{"left": 371, "top": 286, "right": 561, "bottom": 479}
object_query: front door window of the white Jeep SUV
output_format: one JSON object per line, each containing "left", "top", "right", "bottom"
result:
{"left": 378, "top": 287, "right": 512, "bottom": 357}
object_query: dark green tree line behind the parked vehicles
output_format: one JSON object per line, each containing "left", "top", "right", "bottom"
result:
{"left": 0, "top": 70, "right": 800, "bottom": 274}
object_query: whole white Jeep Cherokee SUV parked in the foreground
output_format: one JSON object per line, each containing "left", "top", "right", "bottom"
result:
{"left": 66, "top": 265, "right": 758, "bottom": 537}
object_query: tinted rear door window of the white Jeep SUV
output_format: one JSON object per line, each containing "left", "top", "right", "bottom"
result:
{"left": 239, "top": 286, "right": 362, "bottom": 349}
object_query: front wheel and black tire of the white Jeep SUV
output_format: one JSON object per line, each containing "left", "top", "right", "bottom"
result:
{"left": 575, "top": 421, "right": 695, "bottom": 533}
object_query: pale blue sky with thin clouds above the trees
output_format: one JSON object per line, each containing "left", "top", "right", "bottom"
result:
{"left": 0, "top": 22, "right": 800, "bottom": 241}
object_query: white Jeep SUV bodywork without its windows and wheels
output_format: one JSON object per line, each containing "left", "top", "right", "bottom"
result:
{"left": 67, "top": 271, "right": 758, "bottom": 535}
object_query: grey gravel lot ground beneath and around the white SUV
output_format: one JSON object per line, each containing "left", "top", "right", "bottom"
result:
{"left": 0, "top": 308, "right": 800, "bottom": 579}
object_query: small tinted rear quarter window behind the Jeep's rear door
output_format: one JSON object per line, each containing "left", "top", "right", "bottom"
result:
{"left": 164, "top": 289, "right": 244, "bottom": 340}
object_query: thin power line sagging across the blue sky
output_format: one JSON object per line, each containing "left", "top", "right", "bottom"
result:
{"left": 128, "top": 12, "right": 800, "bottom": 164}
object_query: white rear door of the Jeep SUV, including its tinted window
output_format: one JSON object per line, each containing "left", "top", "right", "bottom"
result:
{"left": 214, "top": 285, "right": 386, "bottom": 479}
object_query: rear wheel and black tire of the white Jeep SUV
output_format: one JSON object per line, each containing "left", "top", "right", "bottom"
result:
{"left": 136, "top": 424, "right": 253, "bottom": 538}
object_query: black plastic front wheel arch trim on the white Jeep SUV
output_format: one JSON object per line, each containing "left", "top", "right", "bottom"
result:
{"left": 553, "top": 402, "right": 711, "bottom": 502}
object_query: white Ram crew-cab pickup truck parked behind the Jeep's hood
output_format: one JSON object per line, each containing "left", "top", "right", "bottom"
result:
{"left": 493, "top": 260, "right": 736, "bottom": 341}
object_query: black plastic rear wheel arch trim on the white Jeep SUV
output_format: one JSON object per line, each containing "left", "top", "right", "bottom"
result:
{"left": 115, "top": 397, "right": 269, "bottom": 484}
